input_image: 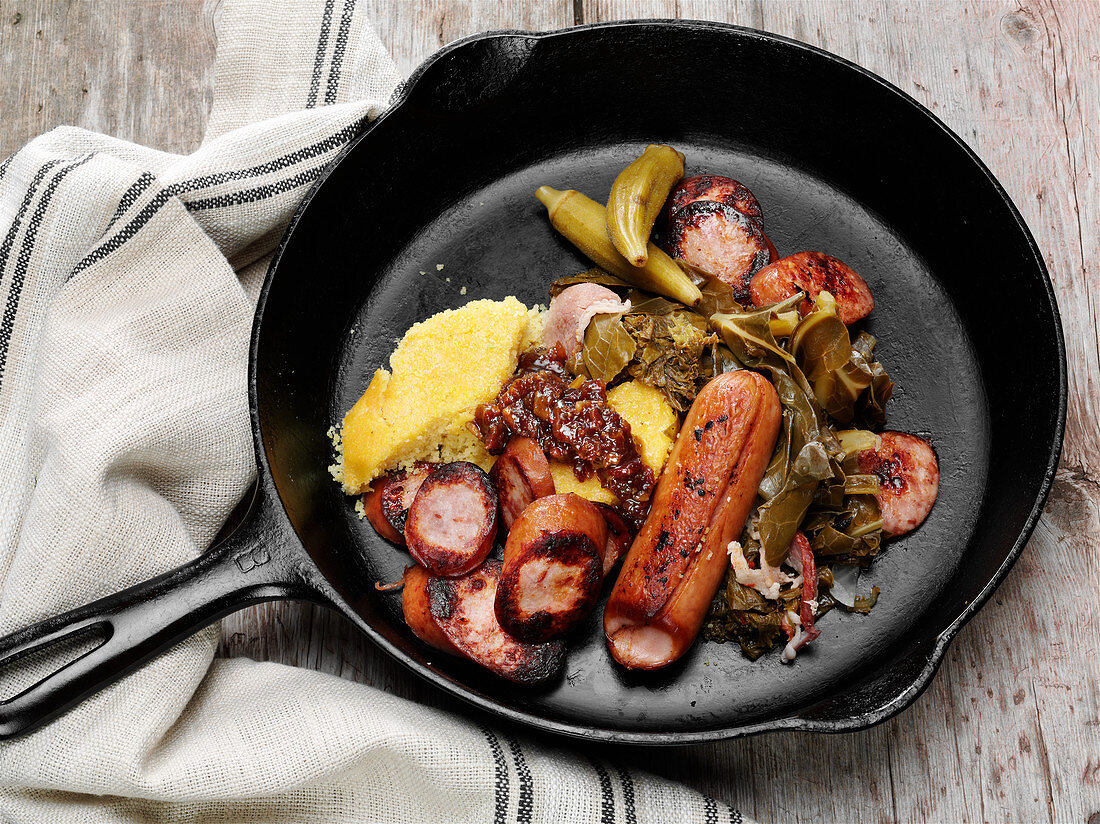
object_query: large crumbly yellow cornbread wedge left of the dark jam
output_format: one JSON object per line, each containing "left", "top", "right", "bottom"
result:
{"left": 333, "top": 297, "right": 542, "bottom": 495}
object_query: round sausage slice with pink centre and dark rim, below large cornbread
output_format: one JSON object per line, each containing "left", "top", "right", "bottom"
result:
{"left": 405, "top": 461, "right": 497, "bottom": 575}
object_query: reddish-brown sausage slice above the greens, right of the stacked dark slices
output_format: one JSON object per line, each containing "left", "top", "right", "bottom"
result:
{"left": 749, "top": 252, "right": 875, "bottom": 325}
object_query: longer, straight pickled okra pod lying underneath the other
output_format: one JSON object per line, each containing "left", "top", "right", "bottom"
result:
{"left": 536, "top": 186, "right": 703, "bottom": 306}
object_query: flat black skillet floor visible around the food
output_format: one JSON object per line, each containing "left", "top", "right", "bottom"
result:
{"left": 331, "top": 143, "right": 989, "bottom": 729}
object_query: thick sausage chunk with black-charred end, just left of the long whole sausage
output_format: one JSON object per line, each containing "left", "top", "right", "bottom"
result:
{"left": 496, "top": 493, "right": 607, "bottom": 642}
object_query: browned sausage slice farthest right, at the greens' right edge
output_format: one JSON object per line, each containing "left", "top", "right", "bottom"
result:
{"left": 858, "top": 431, "right": 939, "bottom": 536}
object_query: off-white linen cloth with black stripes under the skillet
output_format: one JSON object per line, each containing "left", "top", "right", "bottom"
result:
{"left": 0, "top": 0, "right": 743, "bottom": 824}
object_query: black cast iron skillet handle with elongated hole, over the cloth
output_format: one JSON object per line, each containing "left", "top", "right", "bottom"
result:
{"left": 0, "top": 484, "right": 325, "bottom": 740}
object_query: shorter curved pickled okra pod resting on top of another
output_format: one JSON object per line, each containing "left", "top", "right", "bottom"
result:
{"left": 607, "top": 143, "right": 684, "bottom": 266}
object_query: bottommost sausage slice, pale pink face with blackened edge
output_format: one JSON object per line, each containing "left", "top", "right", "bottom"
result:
{"left": 402, "top": 559, "right": 565, "bottom": 684}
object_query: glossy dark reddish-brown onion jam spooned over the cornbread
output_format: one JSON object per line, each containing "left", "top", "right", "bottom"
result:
{"left": 474, "top": 344, "right": 656, "bottom": 527}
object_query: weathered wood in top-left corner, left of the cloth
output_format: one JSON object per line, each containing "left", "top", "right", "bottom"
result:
{"left": 0, "top": 0, "right": 215, "bottom": 156}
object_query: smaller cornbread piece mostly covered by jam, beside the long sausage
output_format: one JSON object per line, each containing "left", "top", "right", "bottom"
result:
{"left": 550, "top": 381, "right": 679, "bottom": 504}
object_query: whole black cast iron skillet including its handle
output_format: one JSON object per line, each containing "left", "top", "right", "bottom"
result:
{"left": 0, "top": 22, "right": 1066, "bottom": 744}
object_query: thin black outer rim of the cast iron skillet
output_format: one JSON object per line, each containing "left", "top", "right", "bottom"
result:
{"left": 249, "top": 19, "right": 1068, "bottom": 745}
